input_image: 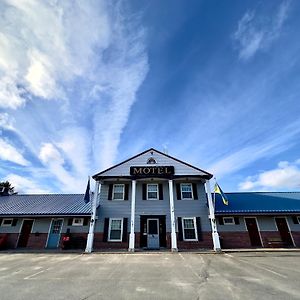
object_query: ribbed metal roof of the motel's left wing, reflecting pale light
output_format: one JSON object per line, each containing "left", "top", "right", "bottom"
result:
{"left": 0, "top": 194, "right": 91, "bottom": 216}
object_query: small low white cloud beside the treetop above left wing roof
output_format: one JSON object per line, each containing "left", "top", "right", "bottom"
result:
{"left": 4, "top": 174, "right": 49, "bottom": 194}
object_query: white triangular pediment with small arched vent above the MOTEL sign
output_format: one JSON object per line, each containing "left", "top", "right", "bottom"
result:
{"left": 93, "top": 148, "right": 212, "bottom": 179}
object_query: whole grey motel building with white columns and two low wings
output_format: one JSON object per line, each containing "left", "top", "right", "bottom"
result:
{"left": 0, "top": 148, "right": 300, "bottom": 252}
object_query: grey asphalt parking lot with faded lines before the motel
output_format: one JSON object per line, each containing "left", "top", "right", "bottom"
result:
{"left": 0, "top": 252, "right": 300, "bottom": 300}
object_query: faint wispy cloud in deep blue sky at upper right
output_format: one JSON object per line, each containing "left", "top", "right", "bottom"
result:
{"left": 233, "top": 1, "right": 290, "bottom": 60}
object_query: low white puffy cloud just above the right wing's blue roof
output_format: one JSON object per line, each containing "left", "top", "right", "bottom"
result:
{"left": 239, "top": 160, "right": 300, "bottom": 190}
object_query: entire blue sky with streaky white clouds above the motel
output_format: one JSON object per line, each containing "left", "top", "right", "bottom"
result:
{"left": 0, "top": 0, "right": 300, "bottom": 193}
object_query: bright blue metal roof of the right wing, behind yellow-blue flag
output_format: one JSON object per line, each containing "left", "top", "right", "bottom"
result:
{"left": 215, "top": 192, "right": 300, "bottom": 215}
